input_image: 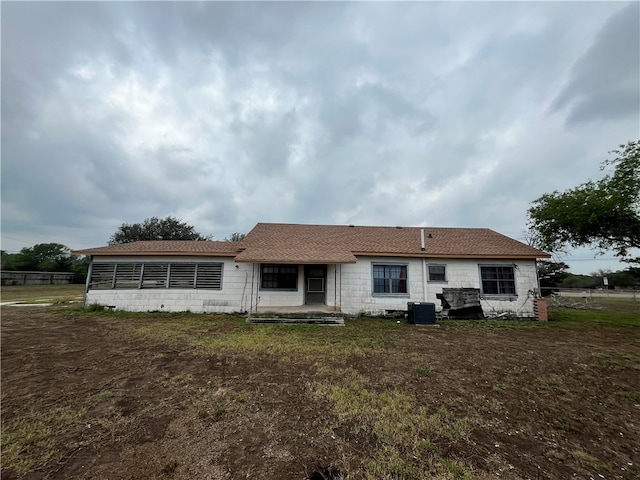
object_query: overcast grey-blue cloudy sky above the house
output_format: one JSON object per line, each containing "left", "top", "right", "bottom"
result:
{"left": 1, "top": 2, "right": 640, "bottom": 273}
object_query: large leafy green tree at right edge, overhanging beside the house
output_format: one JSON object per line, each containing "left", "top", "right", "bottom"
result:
{"left": 528, "top": 140, "right": 640, "bottom": 261}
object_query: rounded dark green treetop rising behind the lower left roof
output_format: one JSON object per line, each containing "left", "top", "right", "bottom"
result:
{"left": 109, "top": 216, "right": 211, "bottom": 245}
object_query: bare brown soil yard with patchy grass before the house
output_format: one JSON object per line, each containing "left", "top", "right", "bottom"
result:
{"left": 1, "top": 306, "right": 640, "bottom": 480}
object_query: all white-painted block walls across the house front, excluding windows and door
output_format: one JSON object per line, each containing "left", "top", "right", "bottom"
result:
{"left": 86, "top": 256, "right": 537, "bottom": 317}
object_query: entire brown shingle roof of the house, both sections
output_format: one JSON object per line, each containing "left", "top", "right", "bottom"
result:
{"left": 74, "top": 223, "right": 549, "bottom": 264}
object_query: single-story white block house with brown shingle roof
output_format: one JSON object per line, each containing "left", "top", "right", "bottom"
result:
{"left": 74, "top": 223, "right": 549, "bottom": 317}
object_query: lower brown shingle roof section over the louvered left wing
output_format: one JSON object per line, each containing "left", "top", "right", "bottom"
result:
{"left": 73, "top": 240, "right": 241, "bottom": 257}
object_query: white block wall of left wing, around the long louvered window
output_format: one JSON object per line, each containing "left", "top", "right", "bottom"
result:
{"left": 85, "top": 256, "right": 255, "bottom": 313}
